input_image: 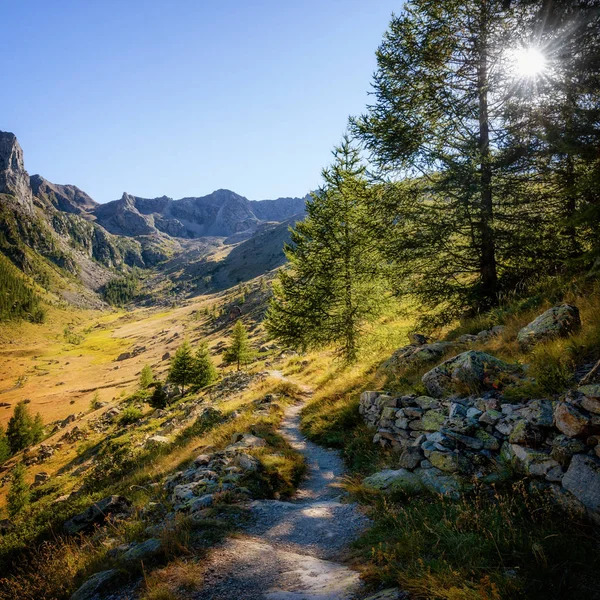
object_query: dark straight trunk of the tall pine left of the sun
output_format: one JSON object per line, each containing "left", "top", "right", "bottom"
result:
{"left": 477, "top": 1, "right": 498, "bottom": 307}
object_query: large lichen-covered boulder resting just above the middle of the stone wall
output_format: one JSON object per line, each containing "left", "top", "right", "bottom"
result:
{"left": 422, "top": 350, "right": 518, "bottom": 398}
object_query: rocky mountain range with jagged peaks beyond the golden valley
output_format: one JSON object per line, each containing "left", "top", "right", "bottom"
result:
{"left": 0, "top": 131, "right": 306, "bottom": 305}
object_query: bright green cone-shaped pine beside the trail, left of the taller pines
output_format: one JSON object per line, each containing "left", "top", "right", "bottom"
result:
{"left": 266, "top": 138, "right": 386, "bottom": 361}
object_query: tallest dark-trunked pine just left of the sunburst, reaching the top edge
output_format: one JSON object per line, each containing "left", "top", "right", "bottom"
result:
{"left": 351, "top": 0, "right": 536, "bottom": 318}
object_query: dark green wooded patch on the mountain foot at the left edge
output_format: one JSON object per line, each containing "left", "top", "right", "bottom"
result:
{"left": 0, "top": 254, "right": 46, "bottom": 323}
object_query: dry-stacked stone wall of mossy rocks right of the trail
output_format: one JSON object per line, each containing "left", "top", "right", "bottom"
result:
{"left": 359, "top": 384, "right": 600, "bottom": 518}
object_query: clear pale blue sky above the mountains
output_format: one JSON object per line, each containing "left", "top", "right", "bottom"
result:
{"left": 0, "top": 0, "right": 401, "bottom": 202}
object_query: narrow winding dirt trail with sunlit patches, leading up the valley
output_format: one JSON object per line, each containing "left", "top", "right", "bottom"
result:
{"left": 195, "top": 372, "right": 367, "bottom": 600}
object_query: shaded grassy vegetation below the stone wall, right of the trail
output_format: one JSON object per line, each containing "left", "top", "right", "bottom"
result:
{"left": 354, "top": 483, "right": 600, "bottom": 600}
